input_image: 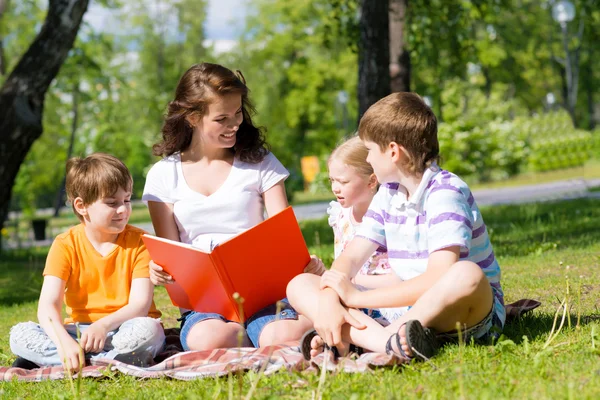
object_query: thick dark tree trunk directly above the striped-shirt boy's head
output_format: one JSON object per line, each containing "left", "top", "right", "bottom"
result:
{"left": 358, "top": 0, "right": 390, "bottom": 119}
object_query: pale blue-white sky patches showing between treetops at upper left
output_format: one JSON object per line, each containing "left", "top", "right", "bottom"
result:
{"left": 84, "top": 0, "right": 247, "bottom": 52}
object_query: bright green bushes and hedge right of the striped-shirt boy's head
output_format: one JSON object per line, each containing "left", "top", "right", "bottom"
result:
{"left": 438, "top": 81, "right": 599, "bottom": 182}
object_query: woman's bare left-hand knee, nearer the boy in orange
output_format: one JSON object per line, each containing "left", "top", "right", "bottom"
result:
{"left": 182, "top": 319, "right": 250, "bottom": 351}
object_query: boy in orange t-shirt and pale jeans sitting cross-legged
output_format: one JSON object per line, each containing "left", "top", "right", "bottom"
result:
{"left": 10, "top": 153, "right": 165, "bottom": 371}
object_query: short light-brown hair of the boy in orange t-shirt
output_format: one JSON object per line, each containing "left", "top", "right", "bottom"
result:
{"left": 66, "top": 153, "right": 133, "bottom": 220}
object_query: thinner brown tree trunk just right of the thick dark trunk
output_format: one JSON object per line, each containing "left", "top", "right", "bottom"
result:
{"left": 389, "top": 0, "right": 411, "bottom": 92}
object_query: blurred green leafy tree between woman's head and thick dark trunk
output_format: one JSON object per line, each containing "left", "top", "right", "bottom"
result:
{"left": 231, "top": 0, "right": 358, "bottom": 180}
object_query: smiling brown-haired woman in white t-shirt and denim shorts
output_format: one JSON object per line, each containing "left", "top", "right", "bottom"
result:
{"left": 143, "top": 63, "right": 322, "bottom": 350}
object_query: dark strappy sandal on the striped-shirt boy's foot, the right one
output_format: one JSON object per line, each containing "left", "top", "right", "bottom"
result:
{"left": 385, "top": 319, "right": 439, "bottom": 361}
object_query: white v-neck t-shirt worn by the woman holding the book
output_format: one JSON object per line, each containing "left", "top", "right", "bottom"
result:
{"left": 142, "top": 153, "right": 289, "bottom": 251}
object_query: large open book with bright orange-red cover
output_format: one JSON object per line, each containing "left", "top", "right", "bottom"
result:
{"left": 142, "top": 207, "right": 310, "bottom": 322}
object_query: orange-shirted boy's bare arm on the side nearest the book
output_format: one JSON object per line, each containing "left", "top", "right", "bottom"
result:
{"left": 80, "top": 278, "right": 154, "bottom": 353}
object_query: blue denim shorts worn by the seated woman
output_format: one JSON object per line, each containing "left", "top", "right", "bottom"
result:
{"left": 178, "top": 299, "right": 298, "bottom": 351}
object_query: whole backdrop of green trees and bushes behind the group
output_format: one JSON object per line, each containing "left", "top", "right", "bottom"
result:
{"left": 0, "top": 0, "right": 600, "bottom": 211}
